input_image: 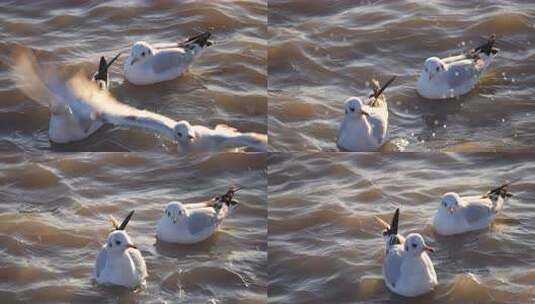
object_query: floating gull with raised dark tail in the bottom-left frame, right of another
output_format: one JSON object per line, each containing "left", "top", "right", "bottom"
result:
{"left": 156, "top": 187, "right": 241, "bottom": 244}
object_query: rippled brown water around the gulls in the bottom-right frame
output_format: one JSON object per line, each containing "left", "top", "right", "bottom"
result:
{"left": 268, "top": 153, "right": 535, "bottom": 303}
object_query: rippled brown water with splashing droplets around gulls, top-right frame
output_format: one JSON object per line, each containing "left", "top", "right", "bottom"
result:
{"left": 268, "top": 0, "right": 535, "bottom": 151}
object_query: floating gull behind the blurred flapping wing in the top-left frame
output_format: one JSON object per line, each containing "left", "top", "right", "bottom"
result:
{"left": 124, "top": 32, "right": 212, "bottom": 85}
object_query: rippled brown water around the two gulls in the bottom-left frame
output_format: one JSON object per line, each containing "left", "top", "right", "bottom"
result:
{"left": 0, "top": 153, "right": 267, "bottom": 303}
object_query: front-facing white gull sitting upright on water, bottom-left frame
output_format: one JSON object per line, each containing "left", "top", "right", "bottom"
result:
{"left": 93, "top": 211, "right": 148, "bottom": 289}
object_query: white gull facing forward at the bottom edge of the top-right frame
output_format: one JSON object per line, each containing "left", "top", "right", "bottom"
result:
{"left": 336, "top": 76, "right": 396, "bottom": 152}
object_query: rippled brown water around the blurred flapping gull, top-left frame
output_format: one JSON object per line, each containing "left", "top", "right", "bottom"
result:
{"left": 0, "top": 0, "right": 267, "bottom": 152}
